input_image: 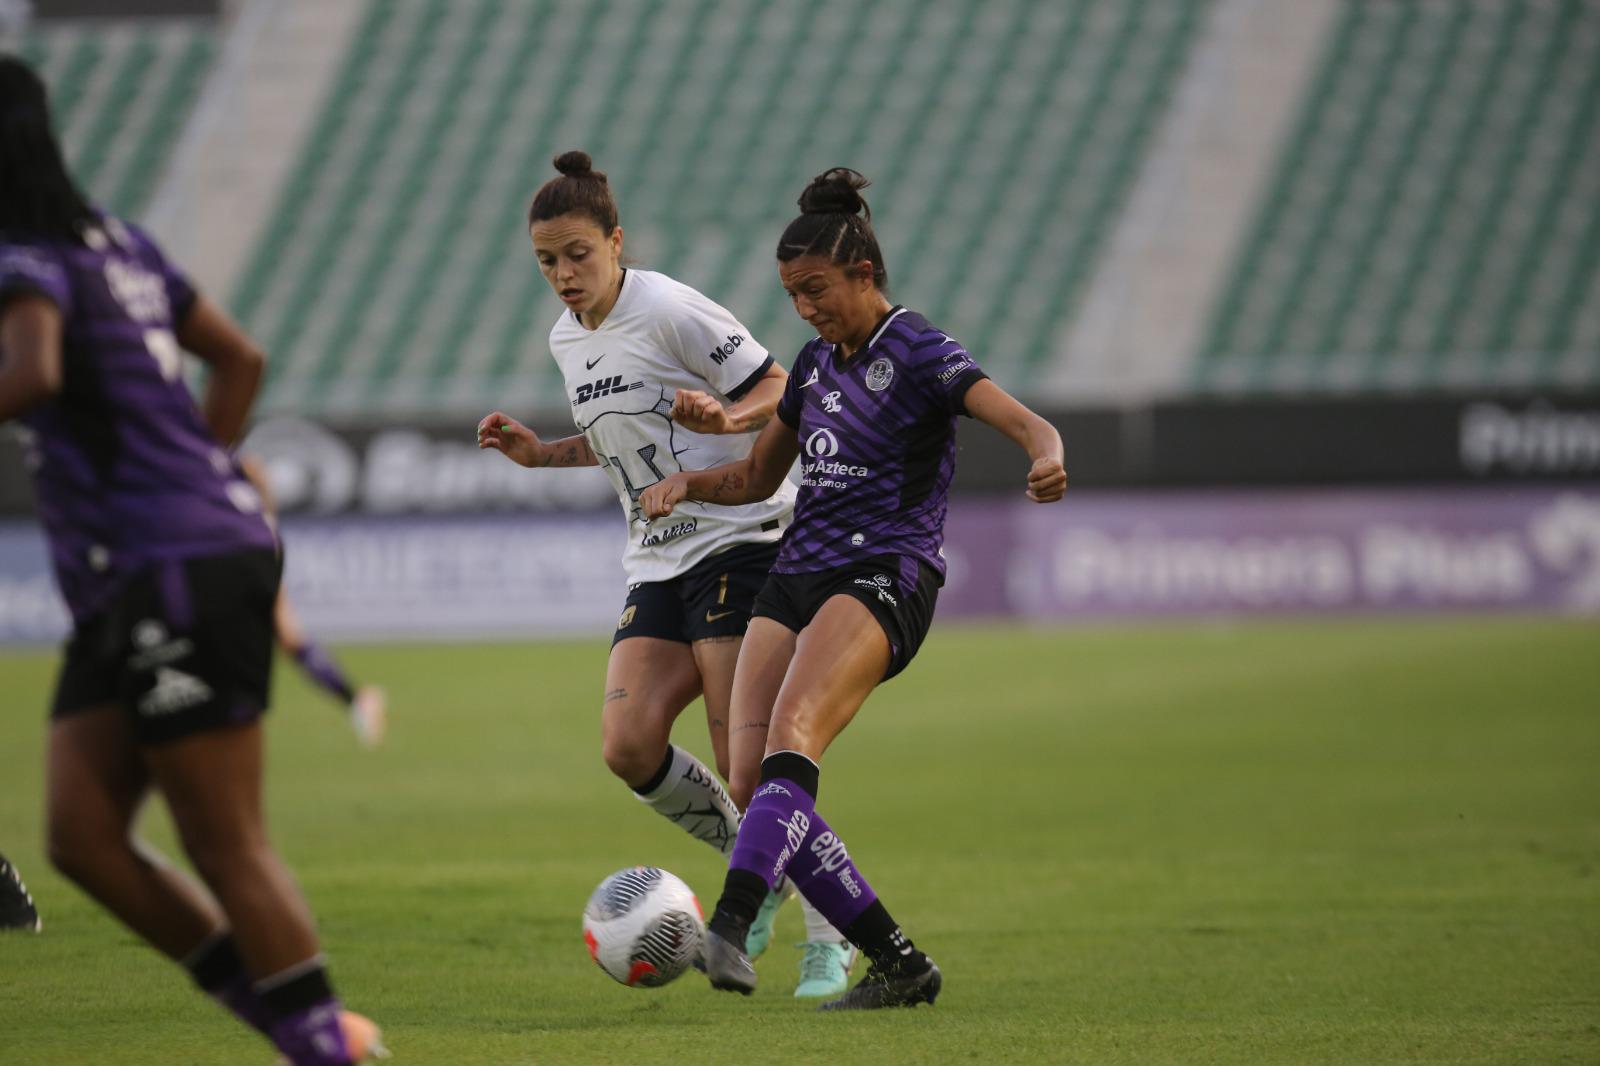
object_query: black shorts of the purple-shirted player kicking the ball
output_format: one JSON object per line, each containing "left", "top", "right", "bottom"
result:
{"left": 755, "top": 555, "right": 944, "bottom": 680}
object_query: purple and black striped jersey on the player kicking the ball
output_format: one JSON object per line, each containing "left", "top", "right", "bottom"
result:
{"left": 773, "top": 307, "right": 989, "bottom": 576}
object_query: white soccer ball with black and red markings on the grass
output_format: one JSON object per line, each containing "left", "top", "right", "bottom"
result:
{"left": 584, "top": 866, "right": 706, "bottom": 988}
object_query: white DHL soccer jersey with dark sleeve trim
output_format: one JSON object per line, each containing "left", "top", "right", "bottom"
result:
{"left": 550, "top": 271, "right": 795, "bottom": 584}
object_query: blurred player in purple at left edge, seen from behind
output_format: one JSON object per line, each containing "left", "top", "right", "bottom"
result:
{"left": 0, "top": 56, "right": 379, "bottom": 1066}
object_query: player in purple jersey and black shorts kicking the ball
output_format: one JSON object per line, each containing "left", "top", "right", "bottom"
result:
{"left": 640, "top": 168, "right": 1067, "bottom": 1010}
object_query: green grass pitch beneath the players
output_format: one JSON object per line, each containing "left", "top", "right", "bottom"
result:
{"left": 0, "top": 619, "right": 1600, "bottom": 1066}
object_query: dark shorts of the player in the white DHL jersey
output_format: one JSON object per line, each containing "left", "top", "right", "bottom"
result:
{"left": 611, "top": 541, "right": 778, "bottom": 647}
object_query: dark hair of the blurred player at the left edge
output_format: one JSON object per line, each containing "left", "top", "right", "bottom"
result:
{"left": 0, "top": 54, "right": 94, "bottom": 238}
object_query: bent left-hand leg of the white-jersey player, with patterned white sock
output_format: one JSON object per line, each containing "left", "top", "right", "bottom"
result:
{"left": 602, "top": 637, "right": 739, "bottom": 855}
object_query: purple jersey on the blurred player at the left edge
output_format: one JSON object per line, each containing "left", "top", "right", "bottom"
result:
{"left": 0, "top": 216, "right": 277, "bottom": 623}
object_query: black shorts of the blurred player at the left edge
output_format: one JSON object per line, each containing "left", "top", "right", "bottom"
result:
{"left": 50, "top": 549, "right": 282, "bottom": 744}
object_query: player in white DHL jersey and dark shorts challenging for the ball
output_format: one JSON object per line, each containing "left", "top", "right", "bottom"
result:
{"left": 478, "top": 152, "right": 853, "bottom": 996}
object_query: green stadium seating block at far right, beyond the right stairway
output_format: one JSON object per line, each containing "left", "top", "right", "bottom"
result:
{"left": 1195, "top": 0, "right": 1600, "bottom": 391}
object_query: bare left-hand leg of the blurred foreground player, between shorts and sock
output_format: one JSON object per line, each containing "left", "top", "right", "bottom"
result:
{"left": 45, "top": 704, "right": 226, "bottom": 959}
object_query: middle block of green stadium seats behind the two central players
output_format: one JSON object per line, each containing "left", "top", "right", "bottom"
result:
{"left": 234, "top": 0, "right": 1210, "bottom": 415}
